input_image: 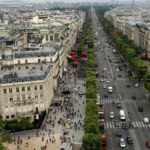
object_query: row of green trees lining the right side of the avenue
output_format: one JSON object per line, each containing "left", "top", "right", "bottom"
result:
{"left": 96, "top": 8, "right": 150, "bottom": 91}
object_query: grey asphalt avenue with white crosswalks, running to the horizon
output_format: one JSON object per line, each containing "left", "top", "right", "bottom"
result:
{"left": 92, "top": 8, "right": 150, "bottom": 150}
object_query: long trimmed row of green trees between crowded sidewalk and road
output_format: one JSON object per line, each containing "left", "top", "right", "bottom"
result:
{"left": 82, "top": 13, "right": 101, "bottom": 150}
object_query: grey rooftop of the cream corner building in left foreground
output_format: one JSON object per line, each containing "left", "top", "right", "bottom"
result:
{"left": 0, "top": 64, "right": 51, "bottom": 84}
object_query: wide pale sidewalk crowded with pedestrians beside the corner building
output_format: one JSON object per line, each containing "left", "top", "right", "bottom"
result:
{"left": 6, "top": 62, "right": 86, "bottom": 150}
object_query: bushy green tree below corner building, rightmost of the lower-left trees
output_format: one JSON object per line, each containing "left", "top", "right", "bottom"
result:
{"left": 19, "top": 117, "right": 33, "bottom": 130}
